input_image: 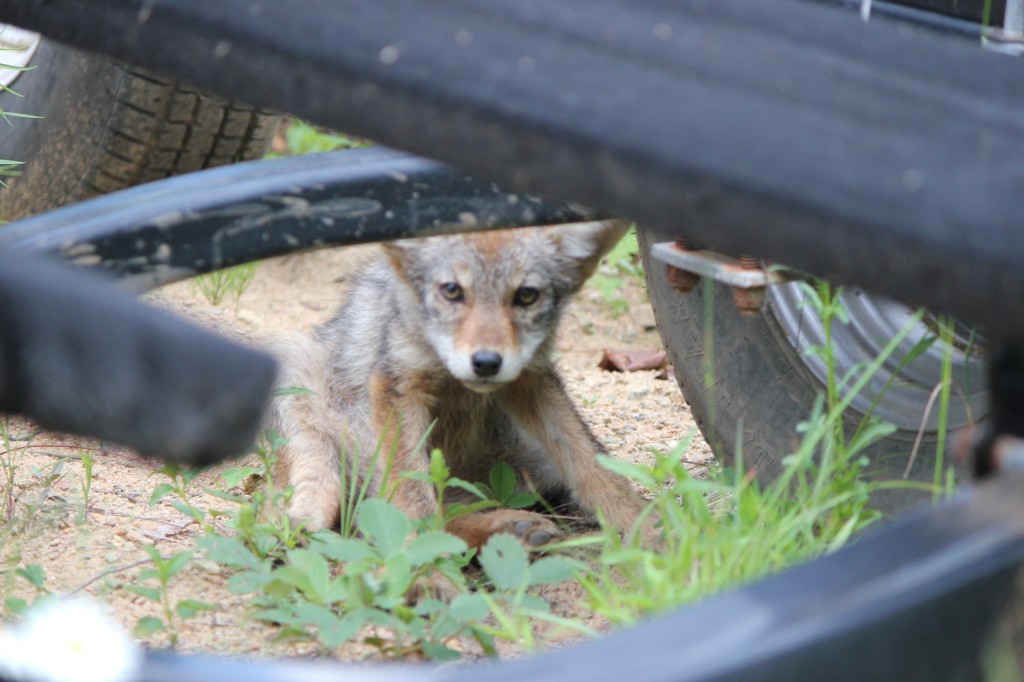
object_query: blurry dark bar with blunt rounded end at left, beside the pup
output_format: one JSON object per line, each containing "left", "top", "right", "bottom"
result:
{"left": 0, "top": 252, "right": 276, "bottom": 464}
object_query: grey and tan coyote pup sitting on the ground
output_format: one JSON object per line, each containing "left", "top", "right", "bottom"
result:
{"left": 274, "top": 221, "right": 643, "bottom": 547}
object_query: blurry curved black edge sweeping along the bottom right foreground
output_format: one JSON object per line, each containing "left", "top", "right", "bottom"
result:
{"left": 128, "top": 476, "right": 1024, "bottom": 682}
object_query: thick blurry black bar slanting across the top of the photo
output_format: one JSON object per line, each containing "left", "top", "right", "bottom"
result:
{"left": 6, "top": 0, "right": 1024, "bottom": 338}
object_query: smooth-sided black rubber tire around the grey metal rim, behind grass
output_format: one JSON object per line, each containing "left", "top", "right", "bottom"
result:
{"left": 638, "top": 222, "right": 968, "bottom": 512}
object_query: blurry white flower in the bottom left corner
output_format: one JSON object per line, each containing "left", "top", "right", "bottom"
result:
{"left": 0, "top": 599, "right": 142, "bottom": 682}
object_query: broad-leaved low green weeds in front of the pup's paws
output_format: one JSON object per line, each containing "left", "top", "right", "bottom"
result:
{"left": 192, "top": 433, "right": 571, "bottom": 659}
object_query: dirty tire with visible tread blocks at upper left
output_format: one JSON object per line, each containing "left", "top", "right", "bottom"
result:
{"left": 0, "top": 40, "right": 280, "bottom": 220}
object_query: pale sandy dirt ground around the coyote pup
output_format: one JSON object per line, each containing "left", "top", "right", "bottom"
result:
{"left": 0, "top": 242, "right": 713, "bottom": 658}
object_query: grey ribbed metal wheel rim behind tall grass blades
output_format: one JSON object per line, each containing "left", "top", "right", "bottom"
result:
{"left": 765, "top": 284, "right": 987, "bottom": 432}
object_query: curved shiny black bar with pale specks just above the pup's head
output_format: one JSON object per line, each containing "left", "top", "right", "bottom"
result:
{"left": 0, "top": 147, "right": 592, "bottom": 290}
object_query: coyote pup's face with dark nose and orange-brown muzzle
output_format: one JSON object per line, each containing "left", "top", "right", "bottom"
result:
{"left": 386, "top": 221, "right": 628, "bottom": 393}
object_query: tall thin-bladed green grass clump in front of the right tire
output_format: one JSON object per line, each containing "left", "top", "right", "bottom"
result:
{"left": 566, "top": 276, "right": 938, "bottom": 625}
